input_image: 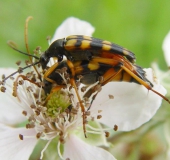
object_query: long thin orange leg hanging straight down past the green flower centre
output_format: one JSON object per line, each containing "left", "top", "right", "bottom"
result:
{"left": 67, "top": 60, "right": 87, "bottom": 138}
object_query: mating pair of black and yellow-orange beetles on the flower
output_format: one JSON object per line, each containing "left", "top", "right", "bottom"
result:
{"left": 4, "top": 35, "right": 170, "bottom": 135}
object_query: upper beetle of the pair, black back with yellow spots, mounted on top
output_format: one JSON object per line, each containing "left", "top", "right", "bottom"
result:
{"left": 40, "top": 35, "right": 135, "bottom": 68}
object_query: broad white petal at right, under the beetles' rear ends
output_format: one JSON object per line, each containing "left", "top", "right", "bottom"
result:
{"left": 91, "top": 69, "right": 166, "bottom": 131}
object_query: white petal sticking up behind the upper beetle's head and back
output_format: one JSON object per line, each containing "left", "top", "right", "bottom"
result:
{"left": 51, "top": 17, "right": 95, "bottom": 42}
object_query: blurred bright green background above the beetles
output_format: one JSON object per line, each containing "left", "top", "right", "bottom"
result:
{"left": 0, "top": 0, "right": 170, "bottom": 69}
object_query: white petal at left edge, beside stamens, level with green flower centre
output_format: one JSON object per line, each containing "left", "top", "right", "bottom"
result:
{"left": 0, "top": 68, "right": 25, "bottom": 125}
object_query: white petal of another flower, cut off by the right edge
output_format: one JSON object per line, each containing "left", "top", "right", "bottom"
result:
{"left": 162, "top": 32, "right": 170, "bottom": 66}
